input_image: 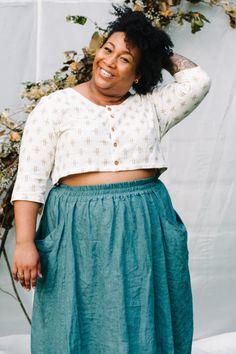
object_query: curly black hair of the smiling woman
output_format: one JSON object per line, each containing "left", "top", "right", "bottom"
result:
{"left": 107, "top": 5, "right": 173, "bottom": 94}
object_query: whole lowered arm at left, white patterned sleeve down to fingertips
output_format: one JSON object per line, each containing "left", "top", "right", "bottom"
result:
{"left": 11, "top": 94, "right": 58, "bottom": 290}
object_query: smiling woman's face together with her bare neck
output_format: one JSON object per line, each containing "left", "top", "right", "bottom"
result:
{"left": 76, "top": 32, "right": 141, "bottom": 105}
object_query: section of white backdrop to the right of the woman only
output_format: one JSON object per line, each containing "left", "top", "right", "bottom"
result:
{"left": 165, "top": 6, "right": 236, "bottom": 338}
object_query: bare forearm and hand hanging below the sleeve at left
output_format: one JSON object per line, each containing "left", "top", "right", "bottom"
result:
{"left": 12, "top": 200, "right": 42, "bottom": 290}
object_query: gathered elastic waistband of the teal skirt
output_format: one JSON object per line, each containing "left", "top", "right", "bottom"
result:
{"left": 53, "top": 176, "right": 160, "bottom": 197}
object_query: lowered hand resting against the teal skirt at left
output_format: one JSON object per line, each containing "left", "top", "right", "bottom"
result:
{"left": 12, "top": 241, "right": 42, "bottom": 291}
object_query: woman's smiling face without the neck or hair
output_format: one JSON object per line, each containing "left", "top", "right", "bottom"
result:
{"left": 92, "top": 32, "right": 140, "bottom": 97}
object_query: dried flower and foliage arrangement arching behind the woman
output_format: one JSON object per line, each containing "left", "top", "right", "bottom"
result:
{"left": 0, "top": 0, "right": 236, "bottom": 323}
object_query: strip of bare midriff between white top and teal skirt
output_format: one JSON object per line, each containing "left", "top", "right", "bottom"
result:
{"left": 59, "top": 169, "right": 158, "bottom": 186}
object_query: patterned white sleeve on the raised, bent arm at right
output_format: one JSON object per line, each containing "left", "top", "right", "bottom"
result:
{"left": 151, "top": 66, "right": 211, "bottom": 138}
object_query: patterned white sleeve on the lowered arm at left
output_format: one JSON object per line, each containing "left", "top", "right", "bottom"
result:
{"left": 11, "top": 97, "right": 58, "bottom": 204}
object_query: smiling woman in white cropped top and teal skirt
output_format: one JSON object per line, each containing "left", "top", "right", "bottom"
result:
{"left": 12, "top": 8, "right": 210, "bottom": 354}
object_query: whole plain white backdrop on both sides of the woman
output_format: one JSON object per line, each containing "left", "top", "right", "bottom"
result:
{"left": 0, "top": 0, "right": 236, "bottom": 353}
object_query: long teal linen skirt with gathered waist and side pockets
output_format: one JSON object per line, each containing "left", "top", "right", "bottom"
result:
{"left": 31, "top": 177, "right": 193, "bottom": 354}
